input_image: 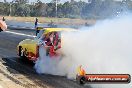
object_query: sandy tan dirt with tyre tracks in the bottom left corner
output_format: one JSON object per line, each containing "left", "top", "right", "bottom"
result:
{"left": 0, "top": 59, "right": 47, "bottom": 88}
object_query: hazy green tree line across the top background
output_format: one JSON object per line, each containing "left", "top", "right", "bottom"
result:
{"left": 0, "top": 0, "right": 132, "bottom": 19}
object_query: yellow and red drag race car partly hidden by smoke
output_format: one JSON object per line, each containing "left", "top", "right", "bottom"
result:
{"left": 17, "top": 27, "right": 75, "bottom": 62}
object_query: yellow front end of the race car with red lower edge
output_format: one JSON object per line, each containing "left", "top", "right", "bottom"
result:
{"left": 17, "top": 39, "right": 38, "bottom": 61}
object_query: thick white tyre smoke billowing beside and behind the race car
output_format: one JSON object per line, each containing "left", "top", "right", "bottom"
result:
{"left": 35, "top": 15, "right": 132, "bottom": 88}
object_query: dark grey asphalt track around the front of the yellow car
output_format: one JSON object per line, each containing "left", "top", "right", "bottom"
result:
{"left": 0, "top": 29, "right": 91, "bottom": 88}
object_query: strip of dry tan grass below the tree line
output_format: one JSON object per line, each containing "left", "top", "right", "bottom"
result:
{"left": 5, "top": 16, "right": 96, "bottom": 25}
